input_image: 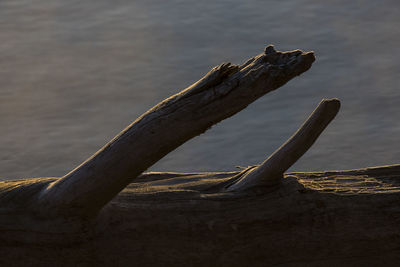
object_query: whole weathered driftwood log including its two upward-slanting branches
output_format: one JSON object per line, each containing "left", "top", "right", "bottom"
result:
{"left": 0, "top": 46, "right": 400, "bottom": 266}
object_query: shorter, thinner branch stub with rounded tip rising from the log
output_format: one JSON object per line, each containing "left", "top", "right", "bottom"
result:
{"left": 227, "top": 98, "right": 340, "bottom": 191}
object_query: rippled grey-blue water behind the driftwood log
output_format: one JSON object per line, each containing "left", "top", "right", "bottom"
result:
{"left": 0, "top": 0, "right": 400, "bottom": 179}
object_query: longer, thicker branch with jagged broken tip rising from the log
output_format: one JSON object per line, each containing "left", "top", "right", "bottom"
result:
{"left": 33, "top": 46, "right": 315, "bottom": 218}
